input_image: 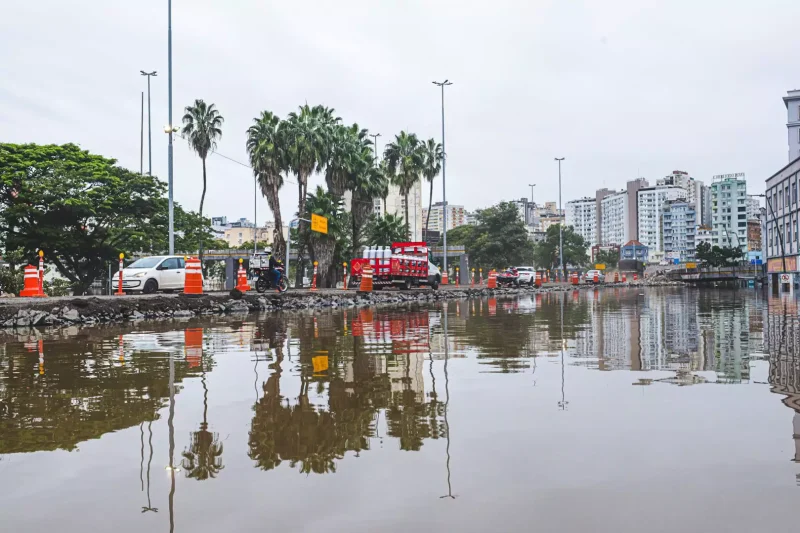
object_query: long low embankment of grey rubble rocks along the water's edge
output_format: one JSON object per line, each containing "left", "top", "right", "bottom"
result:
{"left": 0, "top": 281, "right": 682, "bottom": 328}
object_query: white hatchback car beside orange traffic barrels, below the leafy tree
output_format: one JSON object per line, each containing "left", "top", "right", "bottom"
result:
{"left": 111, "top": 255, "right": 194, "bottom": 294}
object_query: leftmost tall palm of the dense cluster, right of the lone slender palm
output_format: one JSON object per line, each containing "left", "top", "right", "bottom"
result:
{"left": 247, "top": 111, "right": 286, "bottom": 257}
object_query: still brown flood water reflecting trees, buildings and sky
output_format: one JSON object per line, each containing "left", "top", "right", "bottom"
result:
{"left": 0, "top": 289, "right": 800, "bottom": 533}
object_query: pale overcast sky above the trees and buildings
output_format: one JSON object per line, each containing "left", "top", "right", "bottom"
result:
{"left": 0, "top": 0, "right": 800, "bottom": 221}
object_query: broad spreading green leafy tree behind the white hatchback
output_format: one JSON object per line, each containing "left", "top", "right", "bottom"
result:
{"left": 0, "top": 144, "right": 211, "bottom": 294}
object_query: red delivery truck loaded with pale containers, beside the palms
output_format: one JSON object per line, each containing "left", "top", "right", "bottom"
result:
{"left": 350, "top": 242, "right": 442, "bottom": 290}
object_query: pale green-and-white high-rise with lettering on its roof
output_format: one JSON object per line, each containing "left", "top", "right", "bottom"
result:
{"left": 711, "top": 173, "right": 747, "bottom": 252}
